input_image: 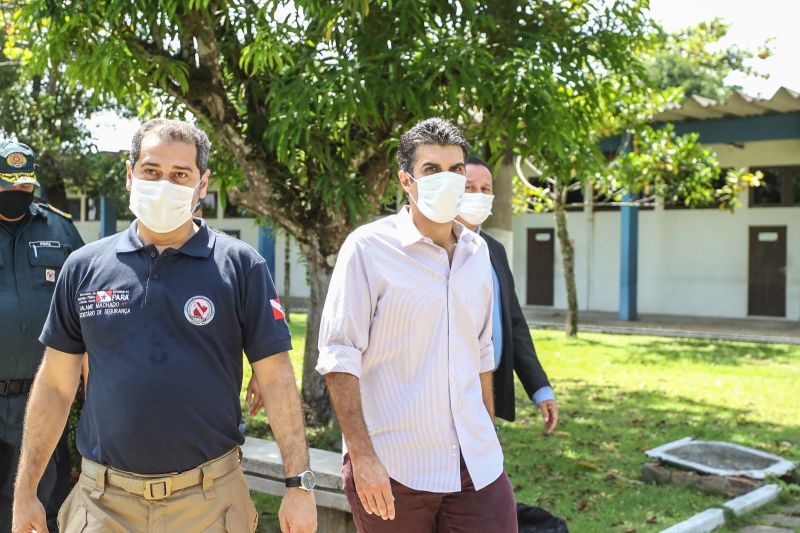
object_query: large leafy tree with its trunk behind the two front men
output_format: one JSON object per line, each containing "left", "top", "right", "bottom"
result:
{"left": 14, "top": 0, "right": 668, "bottom": 420}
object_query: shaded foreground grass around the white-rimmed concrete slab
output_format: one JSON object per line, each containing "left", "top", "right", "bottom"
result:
{"left": 500, "top": 380, "right": 800, "bottom": 532}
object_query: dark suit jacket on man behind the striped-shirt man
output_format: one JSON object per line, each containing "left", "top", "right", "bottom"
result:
{"left": 481, "top": 232, "right": 550, "bottom": 421}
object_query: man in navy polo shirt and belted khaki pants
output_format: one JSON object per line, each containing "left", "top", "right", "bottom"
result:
{"left": 13, "top": 119, "right": 316, "bottom": 533}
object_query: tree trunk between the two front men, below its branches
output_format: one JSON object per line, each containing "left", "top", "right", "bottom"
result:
{"left": 301, "top": 244, "right": 335, "bottom": 426}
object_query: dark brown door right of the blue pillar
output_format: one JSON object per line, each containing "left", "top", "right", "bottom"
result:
{"left": 747, "top": 226, "right": 786, "bottom": 316}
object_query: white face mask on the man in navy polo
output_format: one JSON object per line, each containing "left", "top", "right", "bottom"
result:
{"left": 130, "top": 178, "right": 203, "bottom": 233}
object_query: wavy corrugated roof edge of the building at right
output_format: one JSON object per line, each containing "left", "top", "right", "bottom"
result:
{"left": 654, "top": 87, "right": 800, "bottom": 122}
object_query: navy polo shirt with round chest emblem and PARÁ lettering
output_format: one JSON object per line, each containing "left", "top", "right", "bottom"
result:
{"left": 39, "top": 219, "right": 291, "bottom": 474}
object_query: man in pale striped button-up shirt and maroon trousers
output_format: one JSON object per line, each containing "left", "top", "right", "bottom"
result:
{"left": 317, "top": 119, "right": 517, "bottom": 533}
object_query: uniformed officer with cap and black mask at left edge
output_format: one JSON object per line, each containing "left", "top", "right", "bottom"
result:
{"left": 0, "top": 141, "right": 83, "bottom": 533}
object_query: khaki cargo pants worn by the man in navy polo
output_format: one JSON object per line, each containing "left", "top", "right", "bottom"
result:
{"left": 58, "top": 449, "right": 258, "bottom": 533}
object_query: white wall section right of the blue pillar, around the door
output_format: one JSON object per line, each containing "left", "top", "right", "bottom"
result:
{"left": 639, "top": 201, "right": 800, "bottom": 320}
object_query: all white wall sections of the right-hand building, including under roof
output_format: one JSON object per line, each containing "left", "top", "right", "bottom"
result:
{"left": 512, "top": 140, "right": 800, "bottom": 320}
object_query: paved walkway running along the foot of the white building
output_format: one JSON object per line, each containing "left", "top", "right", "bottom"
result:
{"left": 523, "top": 307, "right": 800, "bottom": 345}
